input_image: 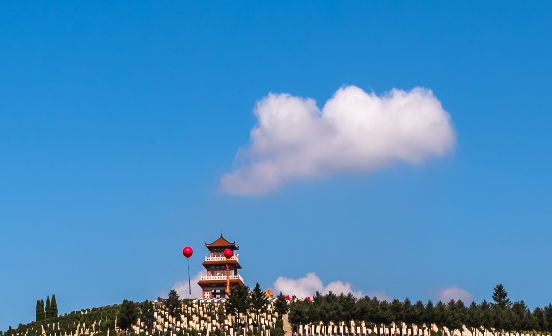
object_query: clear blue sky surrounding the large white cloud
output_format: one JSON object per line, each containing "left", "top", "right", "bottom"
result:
{"left": 0, "top": 1, "right": 552, "bottom": 330}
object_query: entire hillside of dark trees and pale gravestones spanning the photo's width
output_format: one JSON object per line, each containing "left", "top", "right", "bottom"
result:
{"left": 6, "top": 284, "right": 552, "bottom": 336}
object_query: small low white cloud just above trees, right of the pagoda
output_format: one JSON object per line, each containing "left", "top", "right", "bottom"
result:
{"left": 274, "top": 273, "right": 362, "bottom": 299}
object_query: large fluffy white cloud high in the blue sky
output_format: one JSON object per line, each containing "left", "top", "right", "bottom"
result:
{"left": 219, "top": 86, "right": 456, "bottom": 194}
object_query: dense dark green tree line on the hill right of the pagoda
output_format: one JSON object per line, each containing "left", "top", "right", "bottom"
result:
{"left": 289, "top": 284, "right": 552, "bottom": 336}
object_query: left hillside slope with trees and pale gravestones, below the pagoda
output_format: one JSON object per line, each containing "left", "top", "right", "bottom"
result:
{"left": 4, "top": 284, "right": 288, "bottom": 336}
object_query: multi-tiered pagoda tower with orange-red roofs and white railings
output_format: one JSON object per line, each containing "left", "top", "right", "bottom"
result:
{"left": 197, "top": 233, "right": 244, "bottom": 299}
